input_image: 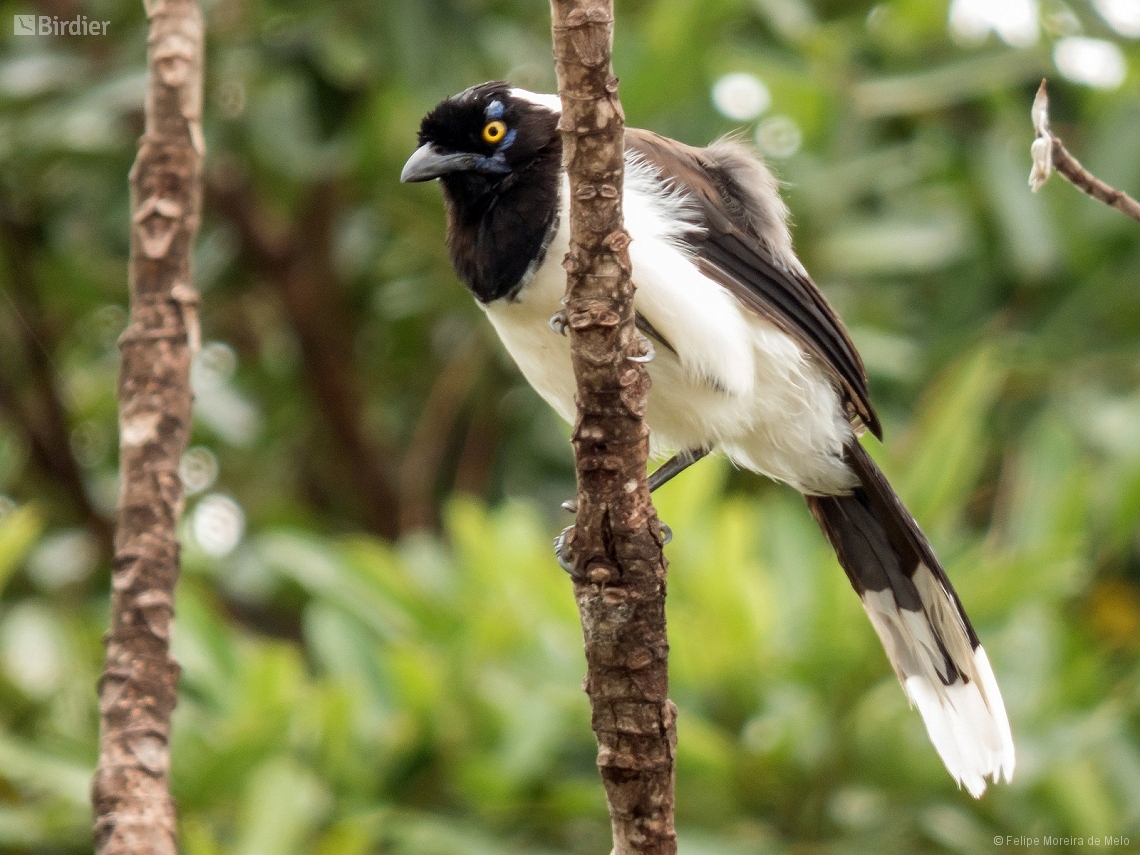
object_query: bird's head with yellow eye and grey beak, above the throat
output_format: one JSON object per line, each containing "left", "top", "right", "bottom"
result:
{"left": 400, "top": 82, "right": 561, "bottom": 201}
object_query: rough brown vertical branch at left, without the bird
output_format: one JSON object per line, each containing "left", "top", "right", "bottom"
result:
{"left": 92, "top": 0, "right": 204, "bottom": 855}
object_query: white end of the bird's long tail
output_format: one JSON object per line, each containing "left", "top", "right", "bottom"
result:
{"left": 862, "top": 565, "right": 1015, "bottom": 798}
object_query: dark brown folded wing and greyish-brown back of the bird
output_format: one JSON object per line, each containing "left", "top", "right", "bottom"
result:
{"left": 626, "top": 128, "right": 882, "bottom": 439}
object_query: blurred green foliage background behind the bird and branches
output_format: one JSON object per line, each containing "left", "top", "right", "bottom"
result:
{"left": 0, "top": 0, "right": 1140, "bottom": 855}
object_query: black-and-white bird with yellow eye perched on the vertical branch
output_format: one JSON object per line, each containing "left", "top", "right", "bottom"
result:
{"left": 400, "top": 81, "right": 1015, "bottom": 798}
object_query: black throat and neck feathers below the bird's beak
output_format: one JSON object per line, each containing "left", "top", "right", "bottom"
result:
{"left": 441, "top": 135, "right": 562, "bottom": 303}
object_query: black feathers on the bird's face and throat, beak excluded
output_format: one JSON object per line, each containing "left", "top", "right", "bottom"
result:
{"left": 420, "top": 82, "right": 562, "bottom": 303}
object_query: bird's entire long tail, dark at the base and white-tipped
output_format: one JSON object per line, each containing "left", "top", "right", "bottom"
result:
{"left": 806, "top": 441, "right": 1013, "bottom": 797}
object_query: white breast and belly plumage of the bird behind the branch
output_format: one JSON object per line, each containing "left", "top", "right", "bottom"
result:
{"left": 483, "top": 161, "right": 854, "bottom": 494}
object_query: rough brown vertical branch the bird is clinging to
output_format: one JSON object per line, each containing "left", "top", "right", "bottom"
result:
{"left": 551, "top": 0, "right": 676, "bottom": 855}
